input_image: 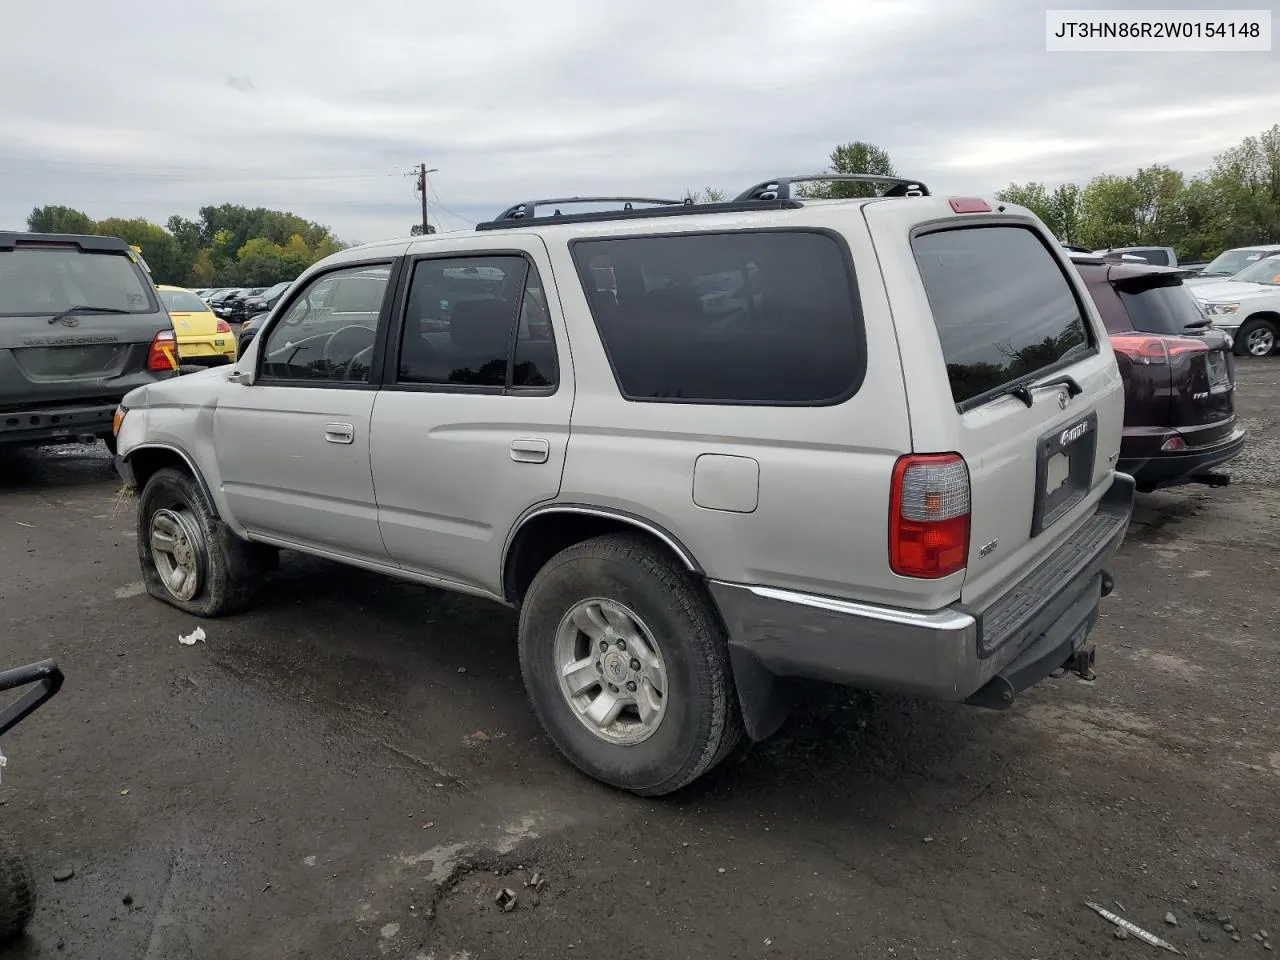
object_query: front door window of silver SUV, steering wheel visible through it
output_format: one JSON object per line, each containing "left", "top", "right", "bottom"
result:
{"left": 253, "top": 264, "right": 390, "bottom": 383}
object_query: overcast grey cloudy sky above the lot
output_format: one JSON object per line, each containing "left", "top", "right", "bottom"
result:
{"left": 0, "top": 0, "right": 1280, "bottom": 241}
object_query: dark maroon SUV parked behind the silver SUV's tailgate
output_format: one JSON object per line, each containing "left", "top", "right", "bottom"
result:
{"left": 1071, "top": 255, "right": 1244, "bottom": 492}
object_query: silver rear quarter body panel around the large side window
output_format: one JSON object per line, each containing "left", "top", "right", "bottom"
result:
{"left": 552, "top": 205, "right": 954, "bottom": 607}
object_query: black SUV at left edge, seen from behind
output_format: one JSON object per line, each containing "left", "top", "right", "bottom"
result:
{"left": 0, "top": 233, "right": 177, "bottom": 447}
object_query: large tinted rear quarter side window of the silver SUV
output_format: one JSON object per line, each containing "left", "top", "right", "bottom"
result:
{"left": 572, "top": 230, "right": 865, "bottom": 406}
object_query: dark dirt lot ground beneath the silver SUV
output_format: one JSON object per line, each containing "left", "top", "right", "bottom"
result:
{"left": 0, "top": 358, "right": 1280, "bottom": 960}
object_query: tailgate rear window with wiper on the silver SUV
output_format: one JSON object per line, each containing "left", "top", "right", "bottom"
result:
{"left": 911, "top": 227, "right": 1093, "bottom": 410}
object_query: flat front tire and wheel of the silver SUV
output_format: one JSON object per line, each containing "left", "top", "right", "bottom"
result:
{"left": 138, "top": 467, "right": 269, "bottom": 617}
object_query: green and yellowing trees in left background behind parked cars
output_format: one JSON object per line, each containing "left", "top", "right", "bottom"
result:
{"left": 27, "top": 204, "right": 346, "bottom": 287}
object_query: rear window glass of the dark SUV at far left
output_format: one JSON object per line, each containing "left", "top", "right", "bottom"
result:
{"left": 0, "top": 246, "right": 155, "bottom": 316}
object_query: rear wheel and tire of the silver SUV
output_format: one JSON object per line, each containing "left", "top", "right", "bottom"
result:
{"left": 520, "top": 534, "right": 742, "bottom": 796}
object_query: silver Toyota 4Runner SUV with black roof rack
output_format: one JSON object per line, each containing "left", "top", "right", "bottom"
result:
{"left": 118, "top": 177, "right": 1134, "bottom": 795}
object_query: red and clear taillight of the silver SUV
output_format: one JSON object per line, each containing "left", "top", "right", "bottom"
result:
{"left": 888, "top": 453, "right": 970, "bottom": 580}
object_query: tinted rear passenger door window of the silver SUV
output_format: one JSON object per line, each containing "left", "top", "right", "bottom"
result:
{"left": 398, "top": 256, "right": 557, "bottom": 389}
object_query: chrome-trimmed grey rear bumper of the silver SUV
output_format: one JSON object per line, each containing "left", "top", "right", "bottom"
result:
{"left": 710, "top": 472, "right": 1134, "bottom": 736}
